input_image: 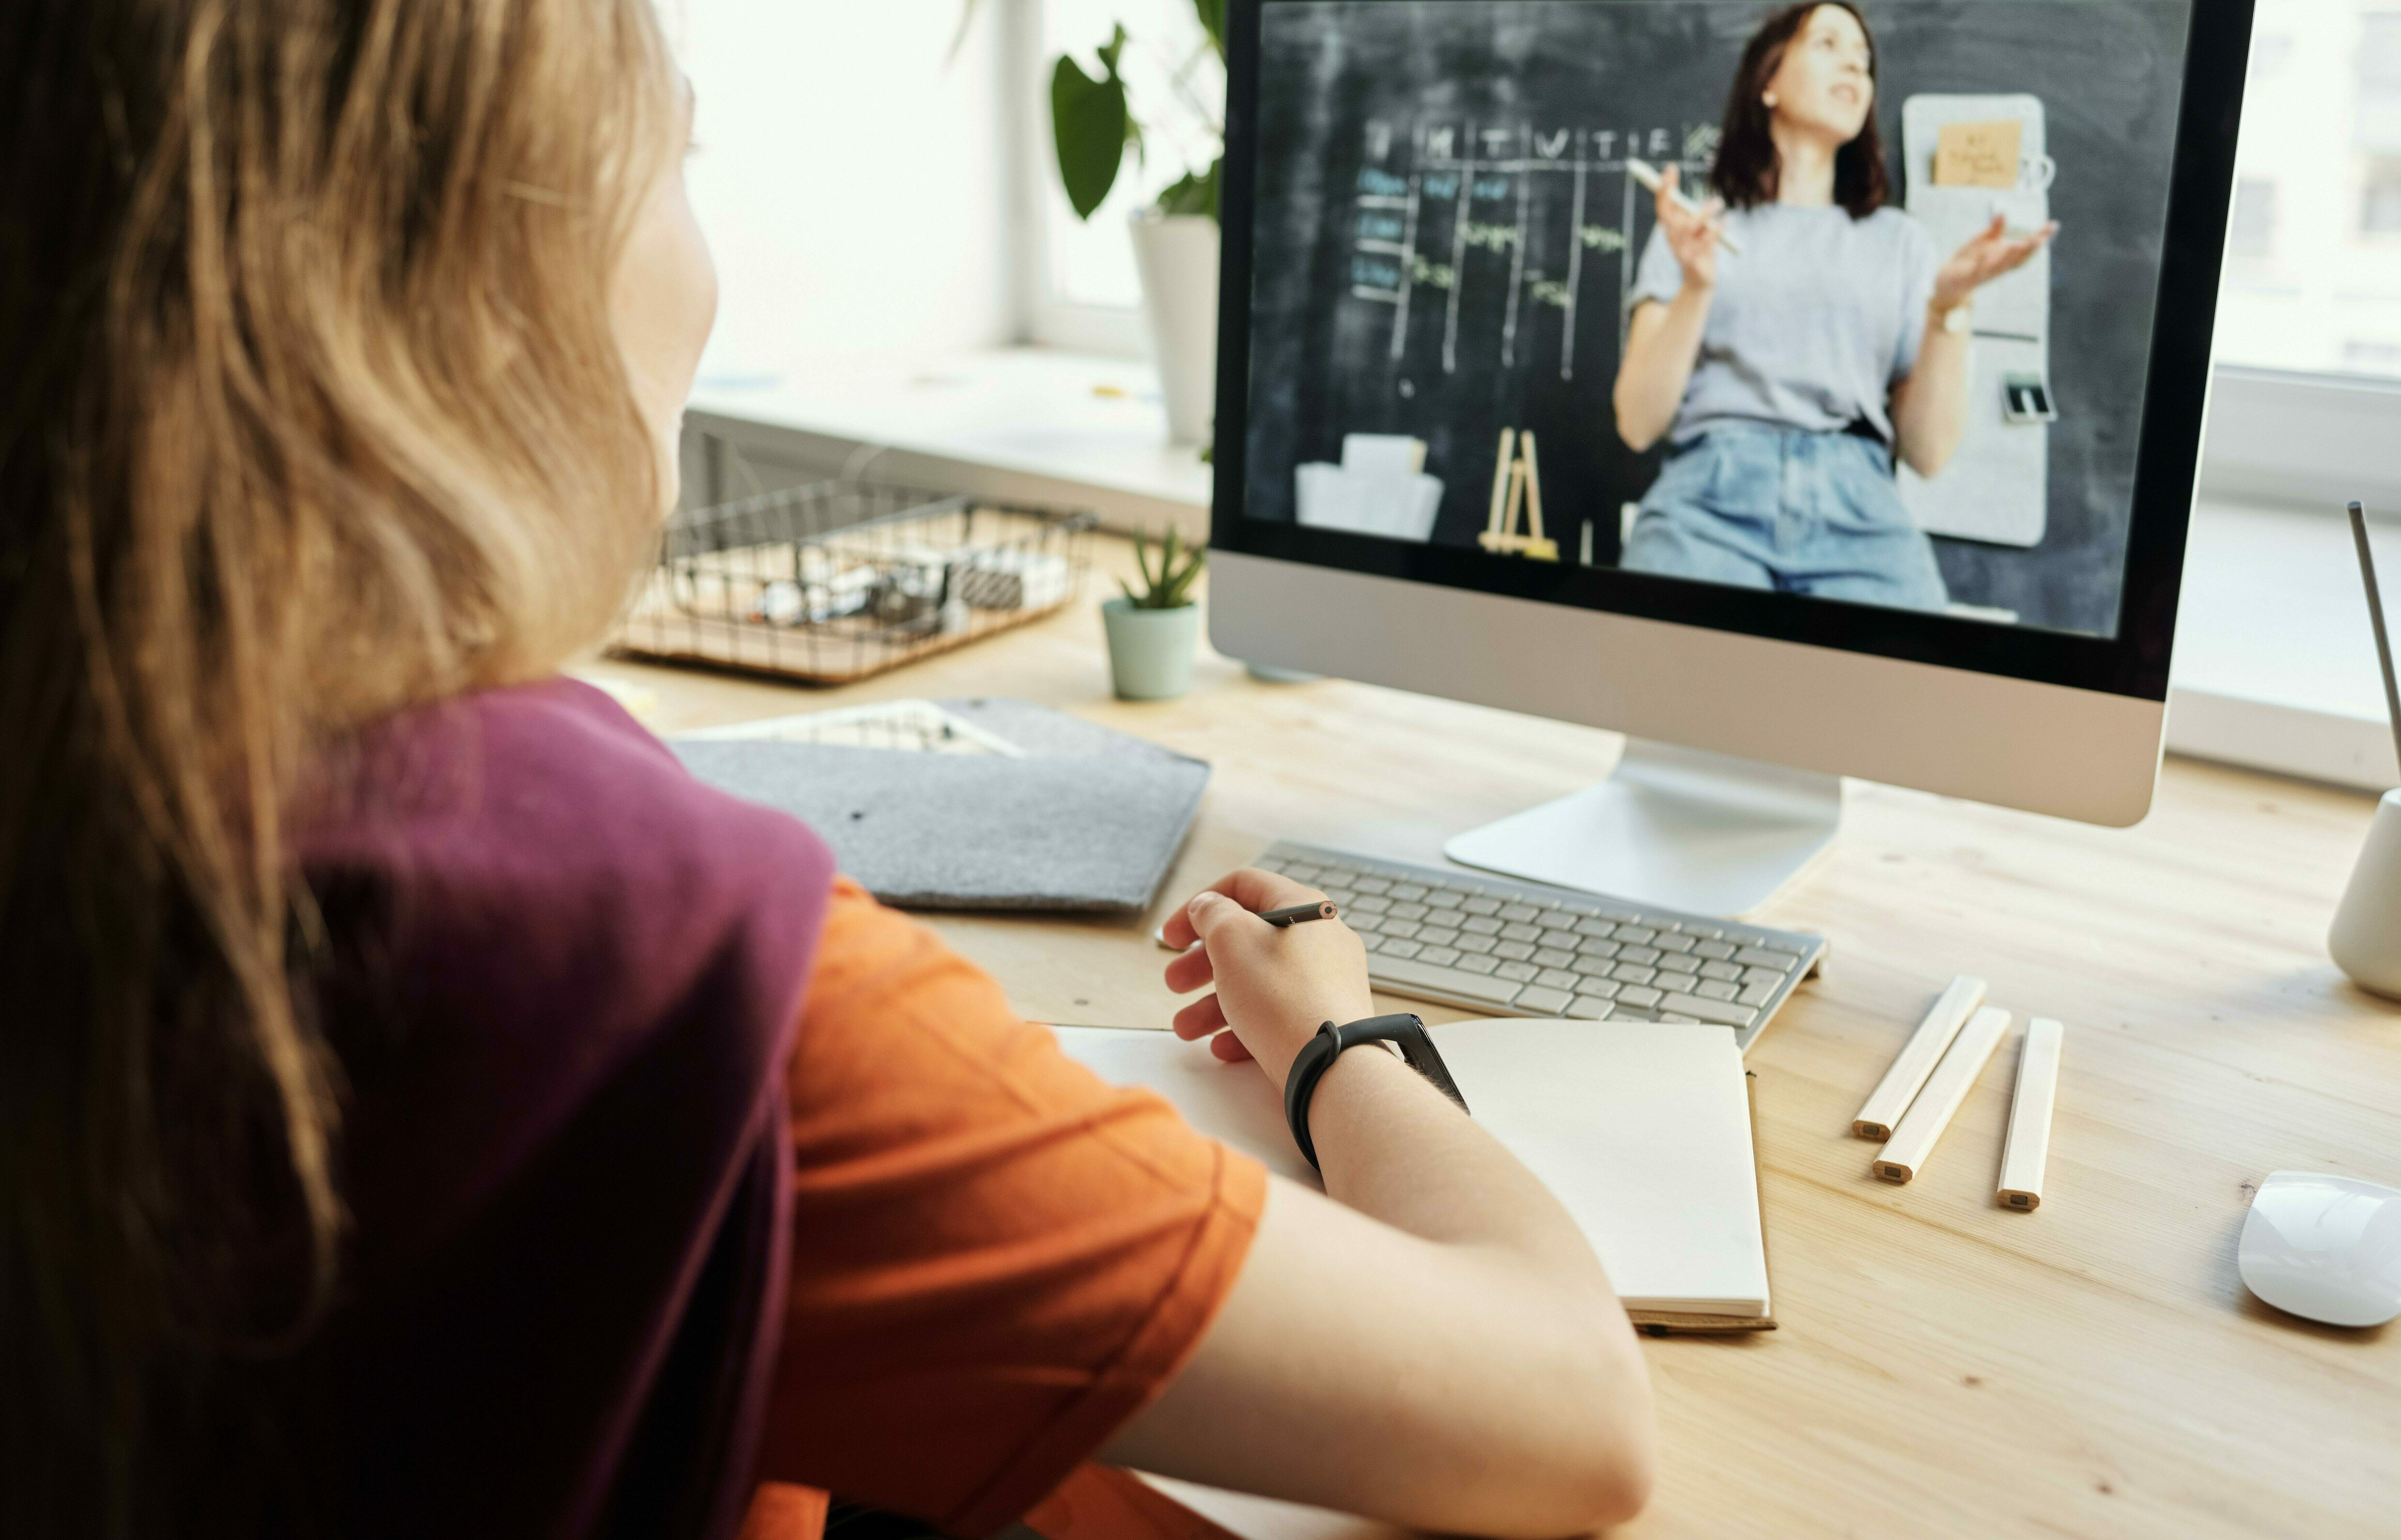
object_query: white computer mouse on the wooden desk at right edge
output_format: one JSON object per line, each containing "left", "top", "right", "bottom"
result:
{"left": 2240, "top": 1170, "right": 2401, "bottom": 1326}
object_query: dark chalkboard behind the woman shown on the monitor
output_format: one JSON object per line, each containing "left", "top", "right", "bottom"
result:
{"left": 1244, "top": 0, "right": 2190, "bottom": 634}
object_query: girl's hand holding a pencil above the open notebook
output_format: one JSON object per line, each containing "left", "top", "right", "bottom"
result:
{"left": 1162, "top": 867, "right": 1376, "bottom": 1091}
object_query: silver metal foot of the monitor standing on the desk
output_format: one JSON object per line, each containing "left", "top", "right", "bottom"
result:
{"left": 1443, "top": 738, "right": 1842, "bottom": 915}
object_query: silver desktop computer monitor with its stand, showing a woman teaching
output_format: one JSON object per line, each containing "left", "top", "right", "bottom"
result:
{"left": 1210, "top": 0, "right": 2250, "bottom": 913}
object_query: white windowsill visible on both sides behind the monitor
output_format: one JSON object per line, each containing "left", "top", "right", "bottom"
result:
{"left": 692, "top": 348, "right": 2401, "bottom": 788}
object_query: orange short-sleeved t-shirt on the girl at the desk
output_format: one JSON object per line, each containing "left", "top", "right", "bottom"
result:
{"left": 744, "top": 879, "right": 1268, "bottom": 1540}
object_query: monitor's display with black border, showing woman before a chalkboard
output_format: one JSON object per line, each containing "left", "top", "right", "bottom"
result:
{"left": 1217, "top": 0, "right": 2247, "bottom": 694}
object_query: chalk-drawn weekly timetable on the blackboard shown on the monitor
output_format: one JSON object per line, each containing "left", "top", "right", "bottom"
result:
{"left": 1349, "top": 118, "right": 1717, "bottom": 380}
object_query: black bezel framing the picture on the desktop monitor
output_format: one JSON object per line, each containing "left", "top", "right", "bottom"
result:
{"left": 1210, "top": 0, "right": 2252, "bottom": 702}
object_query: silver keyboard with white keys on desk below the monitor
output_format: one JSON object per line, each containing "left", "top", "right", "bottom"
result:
{"left": 1258, "top": 841, "right": 1827, "bottom": 1052}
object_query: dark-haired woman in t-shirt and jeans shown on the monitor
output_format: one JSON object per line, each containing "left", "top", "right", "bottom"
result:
{"left": 1616, "top": 0, "right": 2058, "bottom": 610}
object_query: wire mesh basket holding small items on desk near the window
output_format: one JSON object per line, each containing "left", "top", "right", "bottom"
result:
{"left": 612, "top": 480, "right": 1097, "bottom": 685}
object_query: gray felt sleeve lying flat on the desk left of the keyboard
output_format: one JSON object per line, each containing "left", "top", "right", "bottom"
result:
{"left": 667, "top": 699, "right": 1210, "bottom": 913}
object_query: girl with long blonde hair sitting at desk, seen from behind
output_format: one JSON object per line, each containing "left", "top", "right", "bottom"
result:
{"left": 14, "top": 0, "right": 1652, "bottom": 1540}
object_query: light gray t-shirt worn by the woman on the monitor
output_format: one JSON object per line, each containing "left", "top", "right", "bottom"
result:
{"left": 1626, "top": 204, "right": 1942, "bottom": 445}
